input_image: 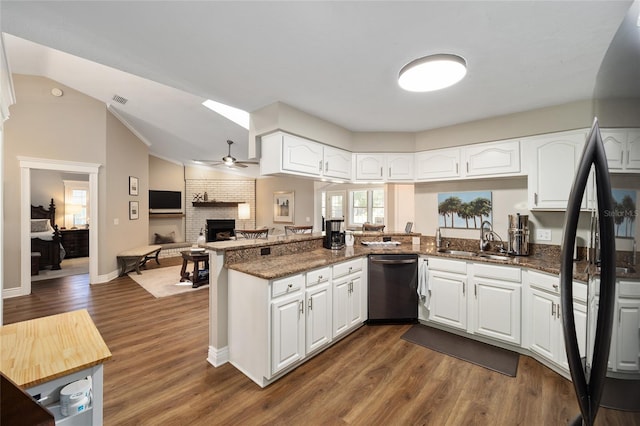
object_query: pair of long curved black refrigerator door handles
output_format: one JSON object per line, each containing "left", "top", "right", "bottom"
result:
{"left": 560, "top": 118, "right": 616, "bottom": 426}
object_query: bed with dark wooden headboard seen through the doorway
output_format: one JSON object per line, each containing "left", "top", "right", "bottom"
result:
{"left": 31, "top": 198, "right": 64, "bottom": 269}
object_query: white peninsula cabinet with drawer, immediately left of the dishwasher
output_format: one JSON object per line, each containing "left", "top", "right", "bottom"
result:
{"left": 333, "top": 258, "right": 366, "bottom": 338}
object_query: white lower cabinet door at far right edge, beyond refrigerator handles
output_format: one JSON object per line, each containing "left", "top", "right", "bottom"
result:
{"left": 616, "top": 298, "right": 640, "bottom": 372}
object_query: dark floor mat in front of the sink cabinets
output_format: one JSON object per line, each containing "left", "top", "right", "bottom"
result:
{"left": 402, "top": 324, "right": 519, "bottom": 377}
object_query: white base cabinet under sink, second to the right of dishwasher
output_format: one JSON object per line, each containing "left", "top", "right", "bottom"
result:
{"left": 469, "top": 263, "right": 522, "bottom": 345}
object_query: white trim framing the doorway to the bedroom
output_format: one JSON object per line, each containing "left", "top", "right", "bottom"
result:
{"left": 19, "top": 158, "right": 100, "bottom": 295}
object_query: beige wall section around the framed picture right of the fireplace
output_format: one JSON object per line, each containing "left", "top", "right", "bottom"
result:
{"left": 256, "top": 177, "right": 320, "bottom": 231}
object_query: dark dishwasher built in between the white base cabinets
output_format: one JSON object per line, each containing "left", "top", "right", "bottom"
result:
{"left": 367, "top": 254, "right": 418, "bottom": 324}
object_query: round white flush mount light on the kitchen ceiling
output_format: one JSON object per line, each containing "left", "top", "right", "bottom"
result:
{"left": 398, "top": 54, "right": 467, "bottom": 92}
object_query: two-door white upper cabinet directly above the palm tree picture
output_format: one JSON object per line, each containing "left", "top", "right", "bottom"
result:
{"left": 416, "top": 140, "right": 521, "bottom": 181}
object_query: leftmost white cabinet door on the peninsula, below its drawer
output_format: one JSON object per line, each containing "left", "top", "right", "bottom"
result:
{"left": 271, "top": 293, "right": 304, "bottom": 374}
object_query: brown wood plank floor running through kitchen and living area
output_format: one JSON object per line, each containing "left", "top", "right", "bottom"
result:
{"left": 4, "top": 259, "right": 640, "bottom": 426}
